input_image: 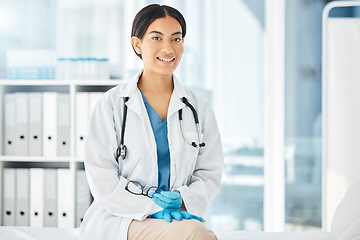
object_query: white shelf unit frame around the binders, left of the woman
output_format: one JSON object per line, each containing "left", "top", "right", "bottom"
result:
{"left": 0, "top": 79, "right": 123, "bottom": 227}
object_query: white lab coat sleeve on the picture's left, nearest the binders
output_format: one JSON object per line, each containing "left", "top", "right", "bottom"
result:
{"left": 85, "top": 95, "right": 161, "bottom": 220}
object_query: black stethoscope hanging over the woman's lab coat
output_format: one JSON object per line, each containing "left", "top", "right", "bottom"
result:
{"left": 116, "top": 97, "right": 205, "bottom": 162}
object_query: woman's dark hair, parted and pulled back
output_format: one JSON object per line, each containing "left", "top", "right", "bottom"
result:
{"left": 131, "top": 4, "right": 186, "bottom": 59}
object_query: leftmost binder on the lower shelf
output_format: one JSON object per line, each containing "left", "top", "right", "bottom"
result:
{"left": 3, "top": 168, "right": 16, "bottom": 226}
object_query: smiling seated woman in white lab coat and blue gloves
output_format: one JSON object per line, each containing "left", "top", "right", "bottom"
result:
{"left": 81, "top": 4, "right": 224, "bottom": 240}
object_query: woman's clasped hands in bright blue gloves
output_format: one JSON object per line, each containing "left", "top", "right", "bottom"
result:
{"left": 151, "top": 191, "right": 202, "bottom": 223}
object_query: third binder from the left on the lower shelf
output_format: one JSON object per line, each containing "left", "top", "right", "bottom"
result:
{"left": 30, "top": 168, "right": 44, "bottom": 227}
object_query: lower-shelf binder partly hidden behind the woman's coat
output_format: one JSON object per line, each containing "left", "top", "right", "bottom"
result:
{"left": 75, "top": 170, "right": 92, "bottom": 227}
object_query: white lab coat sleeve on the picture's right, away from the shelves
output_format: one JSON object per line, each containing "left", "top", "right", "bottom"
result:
{"left": 177, "top": 102, "right": 224, "bottom": 216}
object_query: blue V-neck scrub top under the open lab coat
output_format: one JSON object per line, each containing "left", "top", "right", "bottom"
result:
{"left": 139, "top": 89, "right": 170, "bottom": 191}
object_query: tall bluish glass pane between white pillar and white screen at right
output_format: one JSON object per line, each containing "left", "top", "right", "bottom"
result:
{"left": 285, "top": 0, "right": 326, "bottom": 231}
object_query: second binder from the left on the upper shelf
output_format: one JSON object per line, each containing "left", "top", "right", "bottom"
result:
{"left": 15, "top": 92, "right": 29, "bottom": 156}
